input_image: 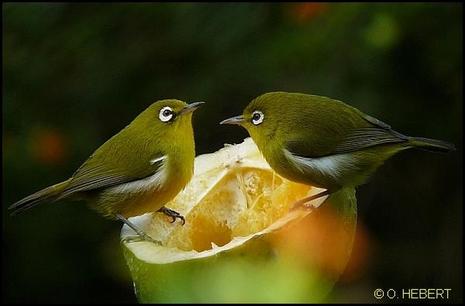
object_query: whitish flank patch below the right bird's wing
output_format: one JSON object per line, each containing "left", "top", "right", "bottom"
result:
{"left": 284, "top": 149, "right": 355, "bottom": 179}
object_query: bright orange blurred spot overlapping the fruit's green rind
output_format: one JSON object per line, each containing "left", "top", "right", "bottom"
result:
{"left": 270, "top": 203, "right": 368, "bottom": 281}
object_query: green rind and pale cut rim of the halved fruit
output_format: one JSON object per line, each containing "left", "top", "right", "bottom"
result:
{"left": 123, "top": 189, "right": 357, "bottom": 303}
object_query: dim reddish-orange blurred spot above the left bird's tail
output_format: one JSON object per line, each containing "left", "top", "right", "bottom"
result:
{"left": 32, "top": 129, "right": 67, "bottom": 164}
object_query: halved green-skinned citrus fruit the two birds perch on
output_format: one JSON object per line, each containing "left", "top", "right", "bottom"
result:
{"left": 121, "top": 138, "right": 356, "bottom": 303}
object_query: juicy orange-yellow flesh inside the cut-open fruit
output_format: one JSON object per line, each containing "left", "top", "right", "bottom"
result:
{"left": 167, "top": 168, "right": 311, "bottom": 252}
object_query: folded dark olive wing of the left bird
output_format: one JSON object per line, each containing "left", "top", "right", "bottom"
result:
{"left": 60, "top": 154, "right": 166, "bottom": 198}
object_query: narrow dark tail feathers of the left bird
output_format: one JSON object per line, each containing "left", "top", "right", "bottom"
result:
{"left": 8, "top": 181, "right": 69, "bottom": 215}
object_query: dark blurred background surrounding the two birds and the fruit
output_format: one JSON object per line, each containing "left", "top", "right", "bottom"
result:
{"left": 2, "top": 3, "right": 463, "bottom": 302}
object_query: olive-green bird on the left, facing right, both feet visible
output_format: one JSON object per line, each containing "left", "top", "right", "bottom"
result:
{"left": 9, "top": 99, "right": 204, "bottom": 241}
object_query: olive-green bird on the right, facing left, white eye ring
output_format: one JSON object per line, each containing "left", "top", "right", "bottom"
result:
{"left": 220, "top": 92, "right": 455, "bottom": 203}
